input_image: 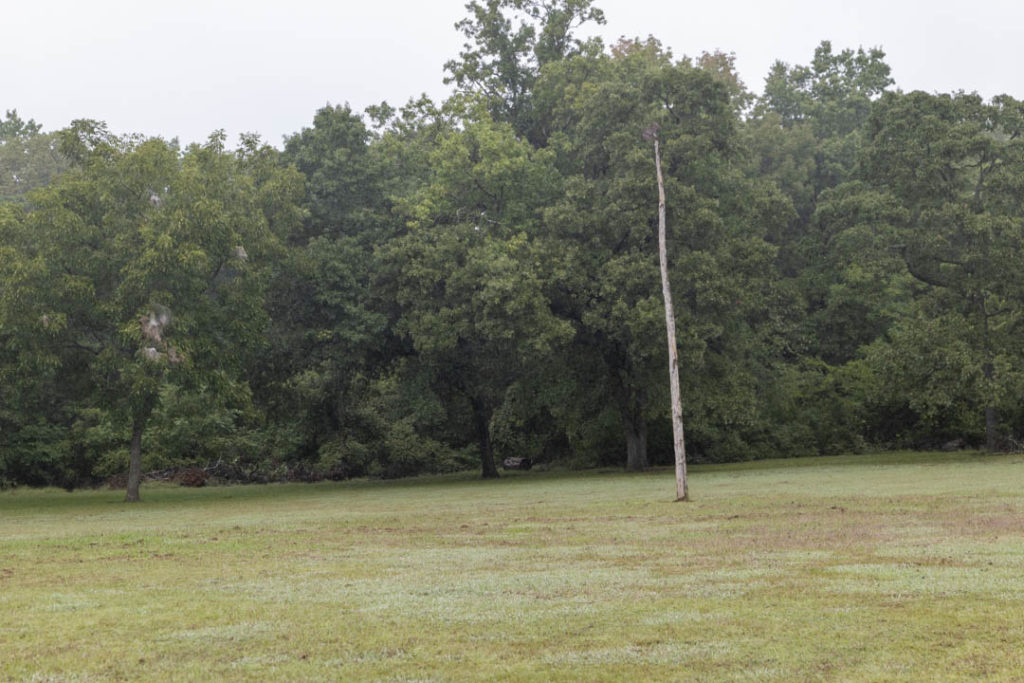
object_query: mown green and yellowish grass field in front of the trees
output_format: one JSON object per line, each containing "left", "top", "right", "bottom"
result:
{"left": 0, "top": 454, "right": 1024, "bottom": 681}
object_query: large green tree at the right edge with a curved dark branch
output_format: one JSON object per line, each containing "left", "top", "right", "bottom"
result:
{"left": 844, "top": 92, "right": 1024, "bottom": 450}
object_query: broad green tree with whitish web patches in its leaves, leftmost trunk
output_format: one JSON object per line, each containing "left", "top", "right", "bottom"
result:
{"left": 0, "top": 121, "right": 273, "bottom": 501}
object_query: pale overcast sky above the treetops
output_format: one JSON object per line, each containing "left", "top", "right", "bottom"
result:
{"left": 8, "top": 0, "right": 1024, "bottom": 145}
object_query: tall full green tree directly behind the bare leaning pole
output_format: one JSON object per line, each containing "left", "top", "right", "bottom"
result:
{"left": 539, "top": 41, "right": 777, "bottom": 469}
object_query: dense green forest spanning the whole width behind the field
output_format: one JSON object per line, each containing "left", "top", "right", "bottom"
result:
{"left": 0, "top": 0, "right": 1024, "bottom": 492}
